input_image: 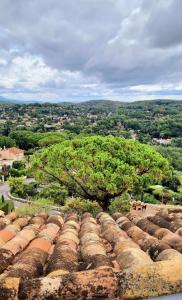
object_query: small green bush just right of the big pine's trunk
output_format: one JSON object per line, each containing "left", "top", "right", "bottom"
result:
{"left": 109, "top": 193, "right": 131, "bottom": 214}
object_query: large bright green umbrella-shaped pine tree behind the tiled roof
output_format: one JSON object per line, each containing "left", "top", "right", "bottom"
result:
{"left": 33, "top": 136, "right": 170, "bottom": 207}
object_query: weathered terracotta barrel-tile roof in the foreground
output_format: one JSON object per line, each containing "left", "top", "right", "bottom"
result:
{"left": 0, "top": 207, "right": 182, "bottom": 300}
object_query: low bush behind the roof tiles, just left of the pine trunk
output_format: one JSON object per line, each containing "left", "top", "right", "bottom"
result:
{"left": 61, "top": 197, "right": 102, "bottom": 216}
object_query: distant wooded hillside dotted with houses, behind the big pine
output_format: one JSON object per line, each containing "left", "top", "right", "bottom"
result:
{"left": 0, "top": 100, "right": 182, "bottom": 171}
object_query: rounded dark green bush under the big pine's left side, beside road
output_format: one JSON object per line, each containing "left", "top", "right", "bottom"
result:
{"left": 39, "top": 183, "right": 68, "bottom": 205}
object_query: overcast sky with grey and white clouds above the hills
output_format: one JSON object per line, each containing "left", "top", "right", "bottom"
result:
{"left": 0, "top": 0, "right": 182, "bottom": 101}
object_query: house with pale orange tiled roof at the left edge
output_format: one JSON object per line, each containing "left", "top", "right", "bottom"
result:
{"left": 0, "top": 147, "right": 25, "bottom": 168}
